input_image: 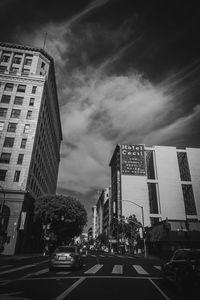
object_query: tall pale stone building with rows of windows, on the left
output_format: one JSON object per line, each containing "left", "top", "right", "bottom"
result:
{"left": 0, "top": 43, "right": 62, "bottom": 254}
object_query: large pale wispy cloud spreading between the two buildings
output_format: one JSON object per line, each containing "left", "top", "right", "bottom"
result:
{"left": 8, "top": 11, "right": 200, "bottom": 210}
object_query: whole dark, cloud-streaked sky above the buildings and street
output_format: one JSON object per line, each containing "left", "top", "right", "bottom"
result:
{"left": 0, "top": 0, "right": 200, "bottom": 227}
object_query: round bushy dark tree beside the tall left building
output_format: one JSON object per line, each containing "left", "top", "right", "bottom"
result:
{"left": 34, "top": 195, "right": 87, "bottom": 243}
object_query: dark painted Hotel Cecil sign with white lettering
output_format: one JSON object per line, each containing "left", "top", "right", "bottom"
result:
{"left": 121, "top": 145, "right": 146, "bottom": 176}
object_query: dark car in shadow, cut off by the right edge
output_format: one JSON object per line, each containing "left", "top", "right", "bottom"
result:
{"left": 162, "top": 249, "right": 200, "bottom": 292}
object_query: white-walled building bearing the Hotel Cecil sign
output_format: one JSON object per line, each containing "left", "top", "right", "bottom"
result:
{"left": 110, "top": 145, "right": 200, "bottom": 228}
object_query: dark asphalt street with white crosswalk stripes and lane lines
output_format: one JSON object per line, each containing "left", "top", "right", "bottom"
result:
{"left": 0, "top": 253, "right": 197, "bottom": 300}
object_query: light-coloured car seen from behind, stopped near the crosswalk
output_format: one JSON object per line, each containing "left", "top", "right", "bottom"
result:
{"left": 49, "top": 246, "right": 83, "bottom": 271}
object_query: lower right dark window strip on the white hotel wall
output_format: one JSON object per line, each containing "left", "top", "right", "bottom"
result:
{"left": 182, "top": 184, "right": 197, "bottom": 215}
